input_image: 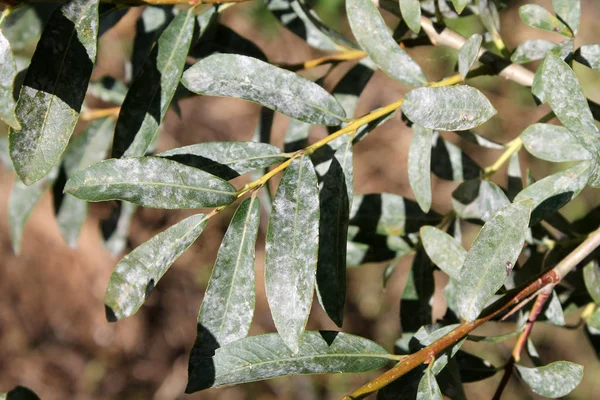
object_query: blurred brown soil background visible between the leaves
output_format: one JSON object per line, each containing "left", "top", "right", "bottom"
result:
{"left": 0, "top": 0, "right": 600, "bottom": 400}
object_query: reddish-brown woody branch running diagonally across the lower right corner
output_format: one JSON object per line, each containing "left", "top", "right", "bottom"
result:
{"left": 344, "top": 228, "right": 600, "bottom": 400}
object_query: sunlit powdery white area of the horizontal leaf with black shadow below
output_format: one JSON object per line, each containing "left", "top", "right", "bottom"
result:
{"left": 158, "top": 142, "right": 287, "bottom": 175}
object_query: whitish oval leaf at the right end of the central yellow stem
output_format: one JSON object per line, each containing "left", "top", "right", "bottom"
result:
{"left": 402, "top": 85, "right": 497, "bottom": 131}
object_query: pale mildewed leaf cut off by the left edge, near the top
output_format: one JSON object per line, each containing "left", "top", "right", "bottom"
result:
{"left": 0, "top": 31, "right": 21, "bottom": 130}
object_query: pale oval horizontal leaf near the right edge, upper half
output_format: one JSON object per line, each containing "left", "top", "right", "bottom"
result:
{"left": 521, "top": 123, "right": 594, "bottom": 162}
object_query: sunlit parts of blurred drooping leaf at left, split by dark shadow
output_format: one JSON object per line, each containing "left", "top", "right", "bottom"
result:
{"left": 56, "top": 118, "right": 114, "bottom": 248}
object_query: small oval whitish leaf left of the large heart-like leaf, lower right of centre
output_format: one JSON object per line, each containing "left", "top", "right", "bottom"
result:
{"left": 421, "top": 226, "right": 467, "bottom": 279}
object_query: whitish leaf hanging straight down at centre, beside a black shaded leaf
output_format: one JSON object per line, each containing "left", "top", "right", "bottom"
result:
{"left": 265, "top": 156, "right": 319, "bottom": 353}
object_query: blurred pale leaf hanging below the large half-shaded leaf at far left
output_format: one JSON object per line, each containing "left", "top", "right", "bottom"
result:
{"left": 8, "top": 168, "right": 58, "bottom": 254}
